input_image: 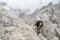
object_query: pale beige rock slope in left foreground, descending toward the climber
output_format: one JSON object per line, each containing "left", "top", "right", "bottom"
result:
{"left": 0, "top": 5, "right": 41, "bottom": 40}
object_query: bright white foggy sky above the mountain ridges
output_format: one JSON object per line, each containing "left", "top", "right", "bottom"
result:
{"left": 0, "top": 0, "right": 59, "bottom": 10}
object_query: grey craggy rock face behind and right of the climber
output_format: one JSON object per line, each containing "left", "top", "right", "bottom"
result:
{"left": 18, "top": 4, "right": 60, "bottom": 40}
